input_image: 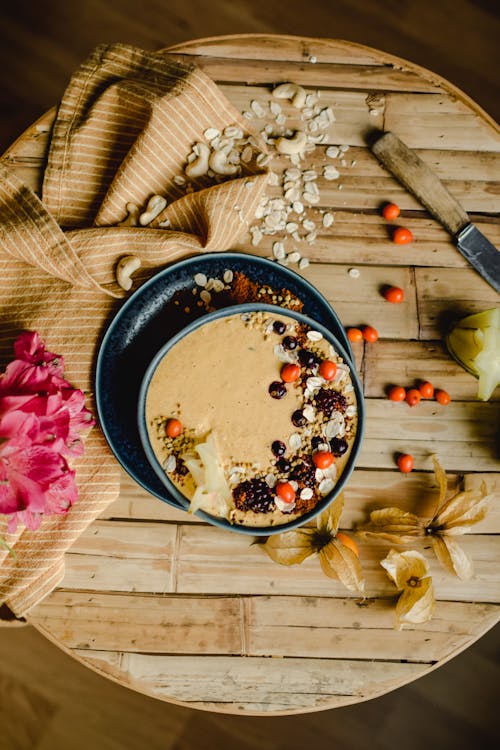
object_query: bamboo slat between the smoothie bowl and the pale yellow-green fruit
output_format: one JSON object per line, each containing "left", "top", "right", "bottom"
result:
{"left": 364, "top": 341, "right": 500, "bottom": 401}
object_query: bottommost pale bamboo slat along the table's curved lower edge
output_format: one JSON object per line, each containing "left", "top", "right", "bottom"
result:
{"left": 106, "top": 652, "right": 425, "bottom": 713}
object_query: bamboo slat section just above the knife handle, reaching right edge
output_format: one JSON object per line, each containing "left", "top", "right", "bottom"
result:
{"left": 384, "top": 93, "right": 500, "bottom": 151}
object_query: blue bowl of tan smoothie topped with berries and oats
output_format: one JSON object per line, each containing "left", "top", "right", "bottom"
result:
{"left": 138, "top": 304, "right": 364, "bottom": 535}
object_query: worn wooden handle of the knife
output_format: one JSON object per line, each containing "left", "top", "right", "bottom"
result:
{"left": 372, "top": 133, "right": 470, "bottom": 235}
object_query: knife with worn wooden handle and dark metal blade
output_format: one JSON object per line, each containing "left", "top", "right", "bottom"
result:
{"left": 371, "top": 132, "right": 500, "bottom": 292}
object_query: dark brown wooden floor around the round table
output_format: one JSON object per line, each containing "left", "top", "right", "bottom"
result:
{"left": 0, "top": 0, "right": 500, "bottom": 750}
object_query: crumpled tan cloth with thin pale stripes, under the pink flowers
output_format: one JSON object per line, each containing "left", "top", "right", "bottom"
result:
{"left": 0, "top": 45, "right": 267, "bottom": 616}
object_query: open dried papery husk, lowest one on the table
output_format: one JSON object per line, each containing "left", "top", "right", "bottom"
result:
{"left": 380, "top": 550, "right": 435, "bottom": 630}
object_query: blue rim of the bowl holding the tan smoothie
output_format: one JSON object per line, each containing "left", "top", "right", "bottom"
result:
{"left": 137, "top": 303, "right": 365, "bottom": 536}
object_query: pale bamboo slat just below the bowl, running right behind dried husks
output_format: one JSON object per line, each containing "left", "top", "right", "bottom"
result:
{"left": 177, "top": 526, "right": 500, "bottom": 603}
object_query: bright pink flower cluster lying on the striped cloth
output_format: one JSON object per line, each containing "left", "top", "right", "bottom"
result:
{"left": 0, "top": 332, "right": 95, "bottom": 531}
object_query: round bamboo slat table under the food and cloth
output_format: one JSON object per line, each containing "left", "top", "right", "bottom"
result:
{"left": 4, "top": 35, "right": 500, "bottom": 715}
